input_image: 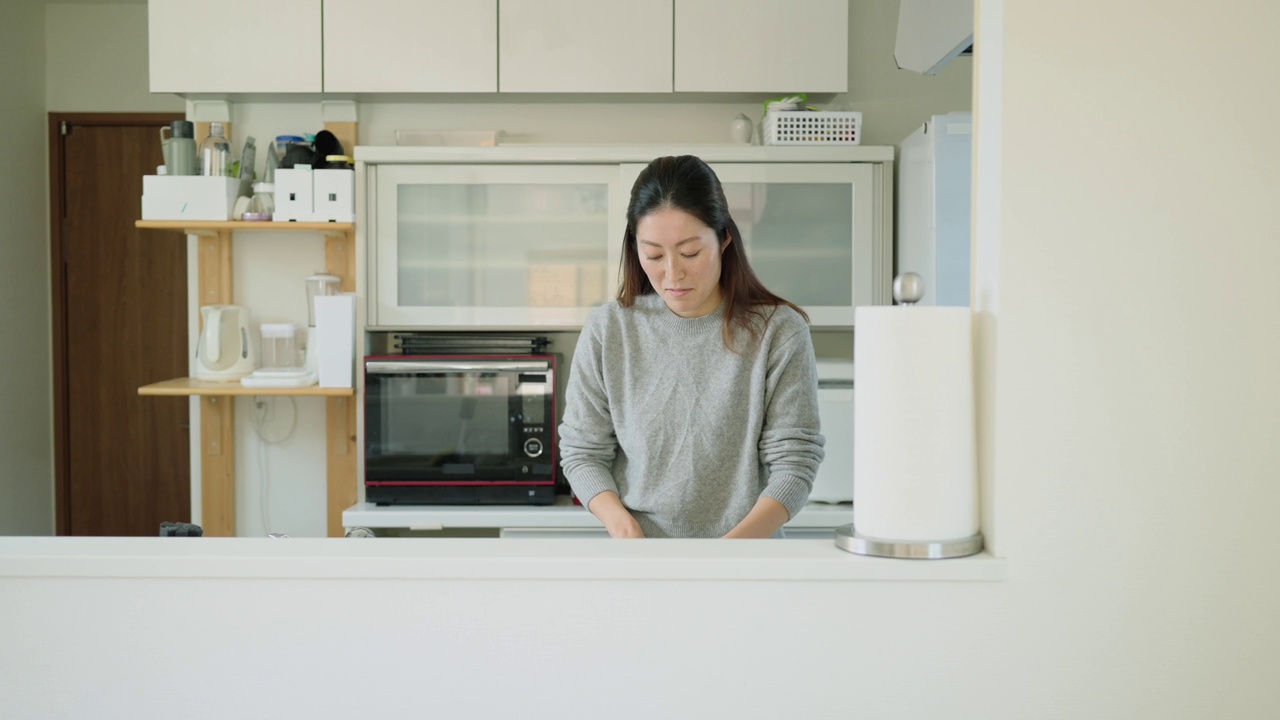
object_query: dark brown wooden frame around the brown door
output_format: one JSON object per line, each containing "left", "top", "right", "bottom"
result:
{"left": 49, "top": 113, "right": 187, "bottom": 536}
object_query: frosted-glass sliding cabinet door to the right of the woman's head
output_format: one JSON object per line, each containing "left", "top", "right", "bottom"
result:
{"left": 622, "top": 163, "right": 888, "bottom": 328}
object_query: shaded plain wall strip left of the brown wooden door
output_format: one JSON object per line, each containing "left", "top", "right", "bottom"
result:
{"left": 0, "top": 3, "right": 54, "bottom": 534}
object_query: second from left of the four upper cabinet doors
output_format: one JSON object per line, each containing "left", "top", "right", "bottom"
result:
{"left": 324, "top": 0, "right": 498, "bottom": 92}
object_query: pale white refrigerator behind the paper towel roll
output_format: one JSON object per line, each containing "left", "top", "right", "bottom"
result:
{"left": 893, "top": 113, "right": 973, "bottom": 306}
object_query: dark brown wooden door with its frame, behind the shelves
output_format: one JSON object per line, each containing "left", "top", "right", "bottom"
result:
{"left": 50, "top": 113, "right": 191, "bottom": 536}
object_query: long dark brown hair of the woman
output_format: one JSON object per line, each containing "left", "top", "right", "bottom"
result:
{"left": 618, "top": 155, "right": 809, "bottom": 350}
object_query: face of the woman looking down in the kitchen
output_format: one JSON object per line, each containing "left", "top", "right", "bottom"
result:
{"left": 636, "top": 208, "right": 723, "bottom": 318}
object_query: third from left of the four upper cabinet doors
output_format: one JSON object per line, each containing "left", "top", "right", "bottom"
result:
{"left": 498, "top": 0, "right": 672, "bottom": 92}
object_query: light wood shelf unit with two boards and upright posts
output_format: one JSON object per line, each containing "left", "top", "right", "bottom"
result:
{"left": 134, "top": 215, "right": 357, "bottom": 537}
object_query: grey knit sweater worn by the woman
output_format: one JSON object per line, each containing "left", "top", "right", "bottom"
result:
{"left": 559, "top": 295, "right": 824, "bottom": 537}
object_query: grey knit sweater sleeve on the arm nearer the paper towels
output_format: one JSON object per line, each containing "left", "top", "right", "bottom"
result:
{"left": 759, "top": 327, "right": 826, "bottom": 518}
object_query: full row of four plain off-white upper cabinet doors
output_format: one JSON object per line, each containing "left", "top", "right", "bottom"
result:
{"left": 147, "top": 0, "right": 849, "bottom": 94}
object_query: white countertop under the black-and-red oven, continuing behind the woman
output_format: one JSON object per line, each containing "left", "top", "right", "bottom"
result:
{"left": 342, "top": 497, "right": 854, "bottom": 530}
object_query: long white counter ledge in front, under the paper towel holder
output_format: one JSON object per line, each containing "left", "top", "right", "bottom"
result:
{"left": 0, "top": 537, "right": 1006, "bottom": 587}
